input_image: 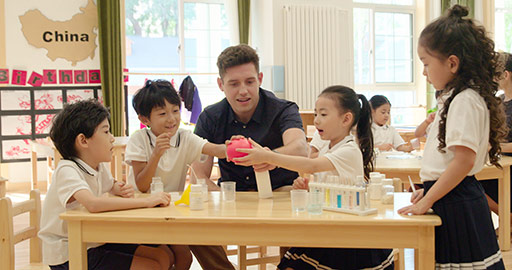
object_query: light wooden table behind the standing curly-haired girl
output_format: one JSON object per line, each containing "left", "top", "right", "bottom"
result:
{"left": 375, "top": 152, "right": 512, "bottom": 251}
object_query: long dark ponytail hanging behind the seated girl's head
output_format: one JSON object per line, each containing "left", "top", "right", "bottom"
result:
{"left": 357, "top": 94, "right": 374, "bottom": 179}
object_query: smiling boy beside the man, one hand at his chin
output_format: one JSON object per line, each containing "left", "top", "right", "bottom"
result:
{"left": 125, "top": 80, "right": 226, "bottom": 270}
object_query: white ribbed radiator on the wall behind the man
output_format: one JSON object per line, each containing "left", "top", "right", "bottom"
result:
{"left": 283, "top": 6, "right": 354, "bottom": 110}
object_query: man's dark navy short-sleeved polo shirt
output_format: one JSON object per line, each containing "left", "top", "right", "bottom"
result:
{"left": 194, "top": 88, "right": 303, "bottom": 191}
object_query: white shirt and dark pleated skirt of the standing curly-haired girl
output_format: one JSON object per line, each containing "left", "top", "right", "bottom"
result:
{"left": 420, "top": 89, "right": 505, "bottom": 269}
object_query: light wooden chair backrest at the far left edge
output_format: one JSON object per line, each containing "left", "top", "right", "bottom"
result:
{"left": 0, "top": 190, "right": 42, "bottom": 270}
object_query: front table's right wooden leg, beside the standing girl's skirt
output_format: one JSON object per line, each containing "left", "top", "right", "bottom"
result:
{"left": 414, "top": 226, "right": 436, "bottom": 269}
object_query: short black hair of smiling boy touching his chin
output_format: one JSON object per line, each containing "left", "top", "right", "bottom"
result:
{"left": 132, "top": 80, "right": 181, "bottom": 117}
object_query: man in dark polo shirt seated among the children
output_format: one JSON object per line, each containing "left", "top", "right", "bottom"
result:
{"left": 191, "top": 44, "right": 307, "bottom": 269}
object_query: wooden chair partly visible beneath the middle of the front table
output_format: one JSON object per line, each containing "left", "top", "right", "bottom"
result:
{"left": 224, "top": 246, "right": 281, "bottom": 270}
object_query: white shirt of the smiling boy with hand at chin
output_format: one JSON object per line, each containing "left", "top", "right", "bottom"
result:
{"left": 125, "top": 128, "right": 208, "bottom": 192}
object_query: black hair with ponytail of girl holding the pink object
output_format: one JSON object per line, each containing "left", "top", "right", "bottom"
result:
{"left": 319, "top": 85, "right": 373, "bottom": 179}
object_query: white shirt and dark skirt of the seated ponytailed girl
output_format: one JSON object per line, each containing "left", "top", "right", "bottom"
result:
{"left": 278, "top": 135, "right": 393, "bottom": 270}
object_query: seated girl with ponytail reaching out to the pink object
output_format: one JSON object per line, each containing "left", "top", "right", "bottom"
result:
{"left": 233, "top": 86, "right": 393, "bottom": 269}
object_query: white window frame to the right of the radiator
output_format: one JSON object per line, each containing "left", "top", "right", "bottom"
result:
{"left": 353, "top": 1, "right": 419, "bottom": 95}
